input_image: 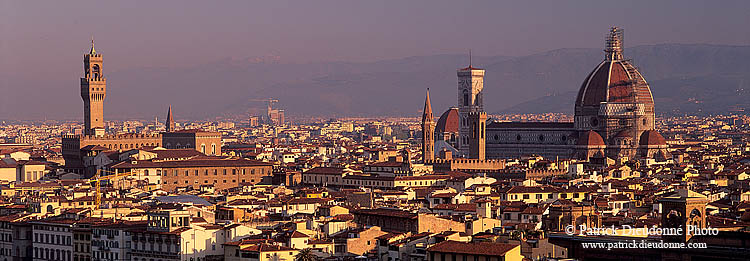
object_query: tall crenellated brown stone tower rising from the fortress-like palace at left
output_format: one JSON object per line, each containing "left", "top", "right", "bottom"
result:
{"left": 81, "top": 38, "right": 107, "bottom": 136}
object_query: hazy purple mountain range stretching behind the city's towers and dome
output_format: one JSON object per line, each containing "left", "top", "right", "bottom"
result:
{"left": 20, "top": 44, "right": 750, "bottom": 120}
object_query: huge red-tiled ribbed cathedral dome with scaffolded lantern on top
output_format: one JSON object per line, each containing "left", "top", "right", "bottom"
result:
{"left": 576, "top": 27, "right": 654, "bottom": 107}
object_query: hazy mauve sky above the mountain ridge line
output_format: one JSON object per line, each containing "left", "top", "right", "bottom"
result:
{"left": 0, "top": 0, "right": 750, "bottom": 118}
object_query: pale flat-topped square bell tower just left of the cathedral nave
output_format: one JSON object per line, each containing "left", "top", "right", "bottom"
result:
{"left": 456, "top": 54, "right": 484, "bottom": 156}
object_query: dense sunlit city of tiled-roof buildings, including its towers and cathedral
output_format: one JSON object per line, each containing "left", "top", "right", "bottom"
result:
{"left": 0, "top": 27, "right": 750, "bottom": 261}
